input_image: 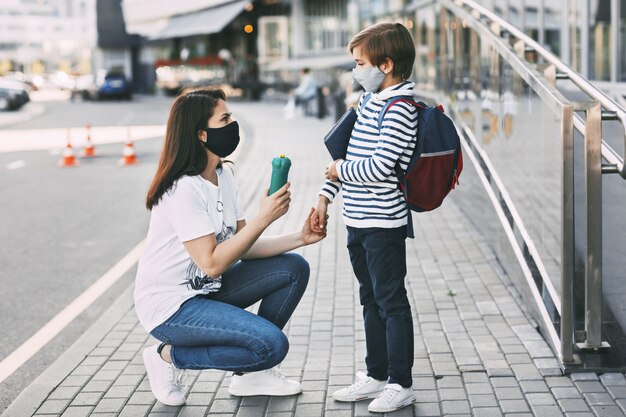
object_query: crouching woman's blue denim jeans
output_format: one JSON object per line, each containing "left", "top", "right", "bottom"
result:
{"left": 151, "top": 253, "right": 309, "bottom": 372}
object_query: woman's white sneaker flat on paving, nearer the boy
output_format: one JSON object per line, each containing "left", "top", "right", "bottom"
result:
{"left": 228, "top": 369, "right": 302, "bottom": 397}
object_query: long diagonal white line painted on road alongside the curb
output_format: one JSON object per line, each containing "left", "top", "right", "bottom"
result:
{"left": 0, "top": 240, "right": 145, "bottom": 383}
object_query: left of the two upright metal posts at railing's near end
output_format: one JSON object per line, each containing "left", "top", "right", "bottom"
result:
{"left": 561, "top": 105, "right": 574, "bottom": 363}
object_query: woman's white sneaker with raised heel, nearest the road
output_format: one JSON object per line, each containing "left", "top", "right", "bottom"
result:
{"left": 143, "top": 345, "right": 185, "bottom": 406}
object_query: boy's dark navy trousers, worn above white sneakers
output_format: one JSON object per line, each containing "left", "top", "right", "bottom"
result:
{"left": 348, "top": 226, "right": 413, "bottom": 388}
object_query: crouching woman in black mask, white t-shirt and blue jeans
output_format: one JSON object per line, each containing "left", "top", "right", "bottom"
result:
{"left": 135, "top": 89, "right": 325, "bottom": 406}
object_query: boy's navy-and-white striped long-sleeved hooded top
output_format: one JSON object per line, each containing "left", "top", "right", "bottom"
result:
{"left": 320, "top": 81, "right": 417, "bottom": 228}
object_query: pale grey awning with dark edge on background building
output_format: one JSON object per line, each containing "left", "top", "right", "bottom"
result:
{"left": 150, "top": 0, "right": 250, "bottom": 39}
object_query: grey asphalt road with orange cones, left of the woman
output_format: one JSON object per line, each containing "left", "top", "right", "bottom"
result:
{"left": 0, "top": 97, "right": 172, "bottom": 413}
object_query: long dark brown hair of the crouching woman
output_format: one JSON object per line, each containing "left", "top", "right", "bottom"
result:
{"left": 146, "top": 89, "right": 226, "bottom": 210}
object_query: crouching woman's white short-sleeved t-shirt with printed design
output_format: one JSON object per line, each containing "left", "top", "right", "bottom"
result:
{"left": 135, "top": 168, "right": 244, "bottom": 332}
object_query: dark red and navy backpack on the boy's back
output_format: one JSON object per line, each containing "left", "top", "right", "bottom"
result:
{"left": 363, "top": 94, "right": 463, "bottom": 238}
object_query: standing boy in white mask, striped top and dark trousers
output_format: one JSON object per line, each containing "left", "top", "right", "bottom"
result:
{"left": 311, "top": 23, "right": 417, "bottom": 413}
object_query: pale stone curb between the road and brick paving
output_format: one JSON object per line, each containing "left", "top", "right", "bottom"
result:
{"left": 2, "top": 285, "right": 134, "bottom": 417}
